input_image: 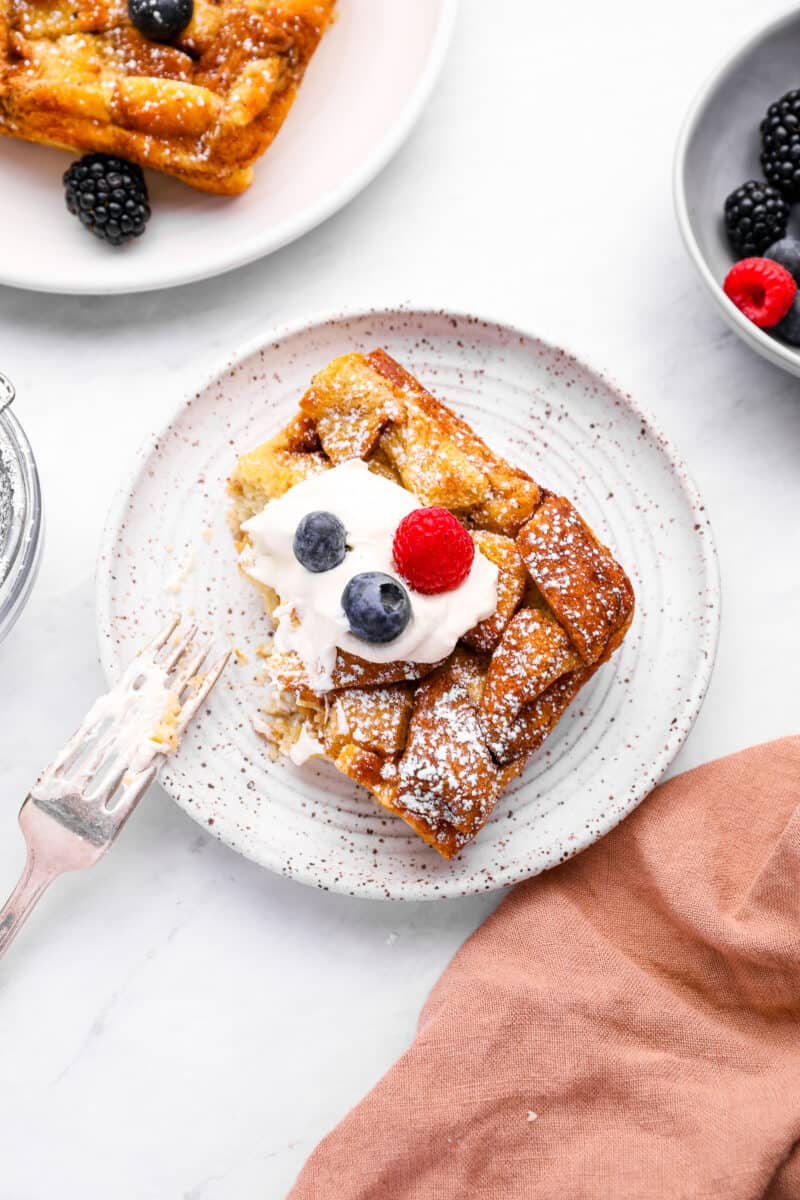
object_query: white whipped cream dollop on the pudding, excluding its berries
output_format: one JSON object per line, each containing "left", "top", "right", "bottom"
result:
{"left": 239, "top": 458, "right": 498, "bottom": 691}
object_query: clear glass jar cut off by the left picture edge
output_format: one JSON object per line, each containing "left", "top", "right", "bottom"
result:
{"left": 0, "top": 374, "right": 42, "bottom": 641}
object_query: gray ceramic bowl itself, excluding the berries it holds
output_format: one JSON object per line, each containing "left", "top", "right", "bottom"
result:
{"left": 674, "top": 8, "right": 800, "bottom": 376}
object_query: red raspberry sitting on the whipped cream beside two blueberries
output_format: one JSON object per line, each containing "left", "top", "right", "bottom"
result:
{"left": 393, "top": 508, "right": 475, "bottom": 595}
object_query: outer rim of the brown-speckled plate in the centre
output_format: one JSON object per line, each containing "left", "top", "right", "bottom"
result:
{"left": 95, "top": 302, "right": 721, "bottom": 900}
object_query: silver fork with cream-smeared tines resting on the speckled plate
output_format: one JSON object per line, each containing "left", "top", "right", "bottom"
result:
{"left": 0, "top": 617, "right": 230, "bottom": 955}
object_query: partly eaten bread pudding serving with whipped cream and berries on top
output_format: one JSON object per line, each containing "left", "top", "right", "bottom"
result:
{"left": 229, "top": 349, "right": 633, "bottom": 858}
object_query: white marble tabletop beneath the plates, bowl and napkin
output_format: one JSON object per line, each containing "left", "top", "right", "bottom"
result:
{"left": 0, "top": 0, "right": 800, "bottom": 1200}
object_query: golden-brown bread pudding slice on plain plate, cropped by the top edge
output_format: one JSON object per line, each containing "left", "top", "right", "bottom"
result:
{"left": 0, "top": 0, "right": 335, "bottom": 194}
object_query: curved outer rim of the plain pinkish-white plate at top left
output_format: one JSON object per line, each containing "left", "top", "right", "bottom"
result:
{"left": 0, "top": 0, "right": 458, "bottom": 295}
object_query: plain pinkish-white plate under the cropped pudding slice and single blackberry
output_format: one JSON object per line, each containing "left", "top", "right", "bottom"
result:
{"left": 0, "top": 0, "right": 456, "bottom": 294}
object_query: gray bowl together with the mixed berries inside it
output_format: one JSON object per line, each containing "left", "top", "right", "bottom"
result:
{"left": 674, "top": 12, "right": 800, "bottom": 374}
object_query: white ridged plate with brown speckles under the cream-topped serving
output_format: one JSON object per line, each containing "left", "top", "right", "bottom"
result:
{"left": 97, "top": 311, "right": 720, "bottom": 900}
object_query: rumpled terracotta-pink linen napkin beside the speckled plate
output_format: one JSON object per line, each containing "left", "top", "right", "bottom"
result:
{"left": 291, "top": 738, "right": 800, "bottom": 1200}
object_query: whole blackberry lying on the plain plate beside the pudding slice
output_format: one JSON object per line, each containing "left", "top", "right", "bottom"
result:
{"left": 64, "top": 154, "right": 150, "bottom": 246}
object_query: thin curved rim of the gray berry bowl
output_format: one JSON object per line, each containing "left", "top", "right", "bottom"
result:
{"left": 673, "top": 7, "right": 800, "bottom": 376}
